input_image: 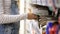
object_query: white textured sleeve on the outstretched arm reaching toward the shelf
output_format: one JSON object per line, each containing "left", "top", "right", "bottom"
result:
{"left": 0, "top": 14, "right": 26, "bottom": 24}
